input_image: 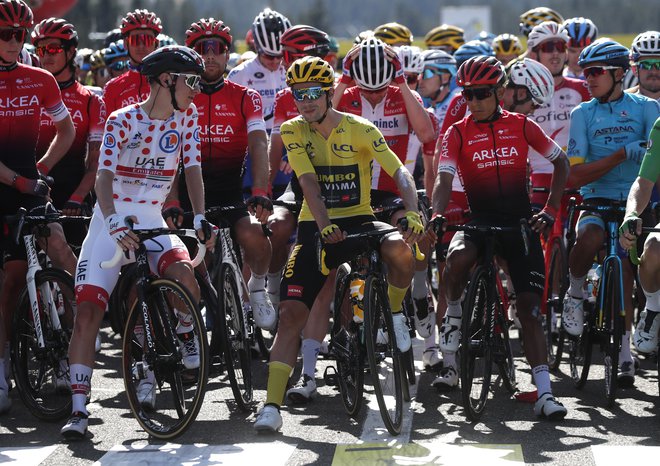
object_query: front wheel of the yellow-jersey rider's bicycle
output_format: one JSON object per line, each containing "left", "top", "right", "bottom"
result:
{"left": 364, "top": 276, "right": 404, "bottom": 435}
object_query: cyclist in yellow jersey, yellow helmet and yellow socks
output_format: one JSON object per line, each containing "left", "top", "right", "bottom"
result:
{"left": 254, "top": 57, "right": 424, "bottom": 432}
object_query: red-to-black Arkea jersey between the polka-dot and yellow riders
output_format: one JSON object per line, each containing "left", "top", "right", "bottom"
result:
{"left": 194, "top": 80, "right": 266, "bottom": 194}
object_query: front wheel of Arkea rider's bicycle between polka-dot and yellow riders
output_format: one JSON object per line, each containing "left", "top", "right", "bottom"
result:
{"left": 215, "top": 264, "right": 253, "bottom": 412}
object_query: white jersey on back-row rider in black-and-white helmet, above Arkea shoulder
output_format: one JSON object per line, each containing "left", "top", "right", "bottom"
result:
{"left": 227, "top": 57, "right": 287, "bottom": 131}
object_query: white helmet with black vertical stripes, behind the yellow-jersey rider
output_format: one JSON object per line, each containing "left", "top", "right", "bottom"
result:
{"left": 351, "top": 37, "right": 394, "bottom": 91}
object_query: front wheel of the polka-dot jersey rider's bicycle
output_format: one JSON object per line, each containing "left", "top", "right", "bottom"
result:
{"left": 122, "top": 279, "right": 209, "bottom": 440}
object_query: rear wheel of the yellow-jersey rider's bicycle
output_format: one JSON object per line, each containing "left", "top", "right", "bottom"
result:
{"left": 331, "top": 264, "right": 364, "bottom": 417}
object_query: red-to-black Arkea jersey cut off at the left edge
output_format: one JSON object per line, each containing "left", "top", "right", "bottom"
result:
{"left": 0, "top": 63, "right": 69, "bottom": 178}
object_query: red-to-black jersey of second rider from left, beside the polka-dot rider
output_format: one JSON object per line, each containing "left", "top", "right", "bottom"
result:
{"left": 37, "top": 81, "right": 106, "bottom": 208}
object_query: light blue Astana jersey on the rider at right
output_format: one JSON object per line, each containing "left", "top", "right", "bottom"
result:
{"left": 566, "top": 93, "right": 660, "bottom": 200}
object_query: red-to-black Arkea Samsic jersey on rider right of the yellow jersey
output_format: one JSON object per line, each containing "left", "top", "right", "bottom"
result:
{"left": 438, "top": 110, "right": 562, "bottom": 221}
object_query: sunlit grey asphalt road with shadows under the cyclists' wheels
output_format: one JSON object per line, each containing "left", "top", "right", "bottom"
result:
{"left": 0, "top": 328, "right": 660, "bottom": 466}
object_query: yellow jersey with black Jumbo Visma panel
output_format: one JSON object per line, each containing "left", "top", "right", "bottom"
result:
{"left": 280, "top": 115, "right": 403, "bottom": 221}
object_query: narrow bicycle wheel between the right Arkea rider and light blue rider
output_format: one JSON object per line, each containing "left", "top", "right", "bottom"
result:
{"left": 543, "top": 238, "right": 568, "bottom": 371}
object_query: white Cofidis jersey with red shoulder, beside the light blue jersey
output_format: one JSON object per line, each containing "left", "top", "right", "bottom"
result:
{"left": 529, "top": 78, "right": 591, "bottom": 174}
